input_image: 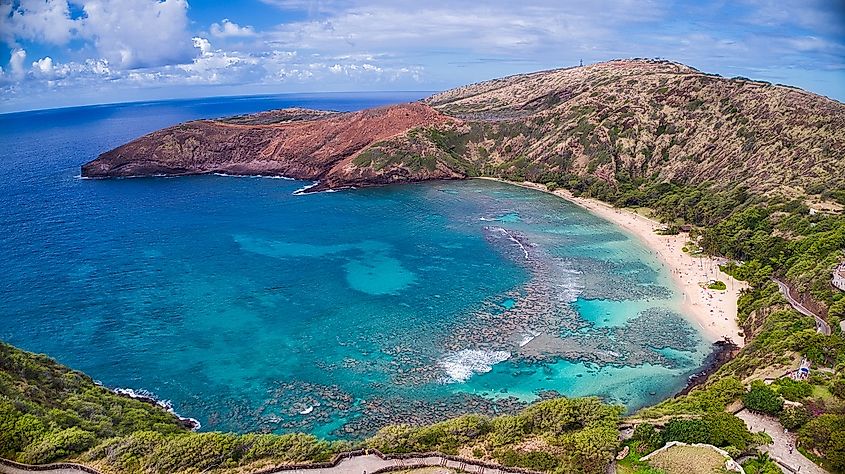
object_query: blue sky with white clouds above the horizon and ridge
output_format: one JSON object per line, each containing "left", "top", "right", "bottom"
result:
{"left": 0, "top": 0, "right": 845, "bottom": 112}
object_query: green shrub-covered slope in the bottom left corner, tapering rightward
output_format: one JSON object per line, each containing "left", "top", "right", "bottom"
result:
{"left": 0, "top": 343, "right": 346, "bottom": 473}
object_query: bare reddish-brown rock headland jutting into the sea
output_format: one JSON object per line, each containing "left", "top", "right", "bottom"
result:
{"left": 82, "top": 103, "right": 462, "bottom": 188}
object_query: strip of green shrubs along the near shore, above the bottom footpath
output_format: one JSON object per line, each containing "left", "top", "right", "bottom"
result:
{"left": 0, "top": 343, "right": 623, "bottom": 473}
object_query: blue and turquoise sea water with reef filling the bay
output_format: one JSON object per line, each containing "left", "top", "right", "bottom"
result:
{"left": 0, "top": 95, "right": 710, "bottom": 437}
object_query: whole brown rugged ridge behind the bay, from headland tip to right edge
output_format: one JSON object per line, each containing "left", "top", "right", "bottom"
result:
{"left": 82, "top": 60, "right": 845, "bottom": 194}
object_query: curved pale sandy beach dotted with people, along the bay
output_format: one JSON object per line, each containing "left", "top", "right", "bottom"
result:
{"left": 481, "top": 178, "right": 746, "bottom": 347}
